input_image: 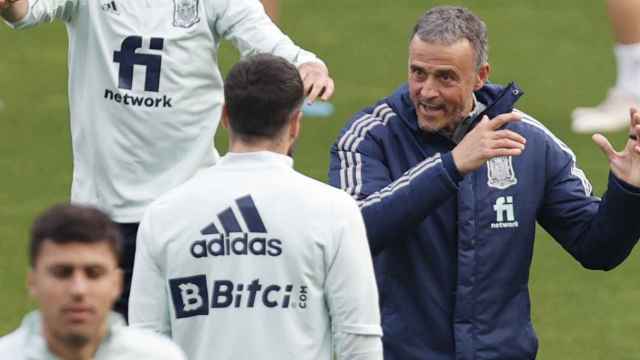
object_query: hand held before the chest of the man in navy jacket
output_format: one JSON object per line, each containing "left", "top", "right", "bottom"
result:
{"left": 452, "top": 112, "right": 527, "bottom": 175}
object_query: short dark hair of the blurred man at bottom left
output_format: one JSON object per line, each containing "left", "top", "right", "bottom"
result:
{"left": 29, "top": 204, "right": 122, "bottom": 268}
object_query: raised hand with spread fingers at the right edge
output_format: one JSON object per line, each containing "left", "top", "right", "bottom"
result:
{"left": 593, "top": 108, "right": 640, "bottom": 187}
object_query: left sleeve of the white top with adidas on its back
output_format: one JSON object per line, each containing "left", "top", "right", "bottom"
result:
{"left": 129, "top": 208, "right": 171, "bottom": 337}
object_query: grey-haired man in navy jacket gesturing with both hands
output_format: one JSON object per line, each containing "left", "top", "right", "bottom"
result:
{"left": 329, "top": 7, "right": 640, "bottom": 360}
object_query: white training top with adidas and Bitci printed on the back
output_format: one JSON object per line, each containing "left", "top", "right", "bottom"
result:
{"left": 129, "top": 151, "right": 382, "bottom": 360}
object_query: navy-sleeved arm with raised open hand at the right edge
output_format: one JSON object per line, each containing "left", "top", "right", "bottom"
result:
{"left": 538, "top": 110, "right": 640, "bottom": 270}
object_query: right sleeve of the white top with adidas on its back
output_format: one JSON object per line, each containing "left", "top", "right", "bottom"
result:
{"left": 325, "top": 198, "right": 382, "bottom": 360}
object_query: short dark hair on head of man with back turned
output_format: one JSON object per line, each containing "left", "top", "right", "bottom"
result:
{"left": 224, "top": 54, "right": 304, "bottom": 141}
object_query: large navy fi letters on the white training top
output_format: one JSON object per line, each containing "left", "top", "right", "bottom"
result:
{"left": 113, "top": 36, "right": 164, "bottom": 92}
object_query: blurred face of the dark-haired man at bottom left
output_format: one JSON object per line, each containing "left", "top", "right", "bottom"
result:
{"left": 28, "top": 240, "right": 122, "bottom": 344}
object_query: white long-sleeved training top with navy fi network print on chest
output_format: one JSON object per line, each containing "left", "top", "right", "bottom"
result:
{"left": 5, "top": 0, "right": 320, "bottom": 223}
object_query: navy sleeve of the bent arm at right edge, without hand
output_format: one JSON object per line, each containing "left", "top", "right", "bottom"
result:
{"left": 538, "top": 131, "right": 640, "bottom": 270}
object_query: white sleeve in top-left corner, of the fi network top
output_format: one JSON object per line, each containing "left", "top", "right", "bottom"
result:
{"left": 5, "top": 0, "right": 81, "bottom": 29}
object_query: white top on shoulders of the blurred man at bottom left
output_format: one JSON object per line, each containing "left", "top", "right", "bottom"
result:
{"left": 0, "top": 311, "right": 187, "bottom": 360}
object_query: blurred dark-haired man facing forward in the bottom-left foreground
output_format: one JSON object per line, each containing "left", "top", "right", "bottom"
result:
{"left": 0, "top": 205, "right": 186, "bottom": 360}
